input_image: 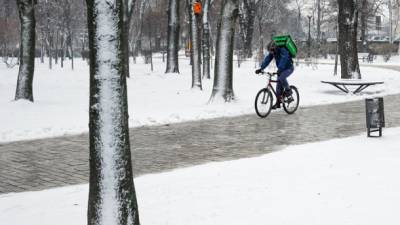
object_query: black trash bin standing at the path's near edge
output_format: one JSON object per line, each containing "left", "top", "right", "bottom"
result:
{"left": 365, "top": 97, "right": 385, "bottom": 137}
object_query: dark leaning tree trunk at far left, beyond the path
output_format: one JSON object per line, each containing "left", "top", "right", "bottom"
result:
{"left": 15, "top": 0, "right": 36, "bottom": 102}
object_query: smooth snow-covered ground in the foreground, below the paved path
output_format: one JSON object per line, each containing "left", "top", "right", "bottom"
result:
{"left": 0, "top": 128, "right": 400, "bottom": 225}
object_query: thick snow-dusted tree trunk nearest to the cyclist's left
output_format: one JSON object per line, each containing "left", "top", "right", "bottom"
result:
{"left": 210, "top": 0, "right": 239, "bottom": 102}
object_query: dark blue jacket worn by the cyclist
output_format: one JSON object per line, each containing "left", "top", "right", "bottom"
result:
{"left": 261, "top": 47, "right": 293, "bottom": 72}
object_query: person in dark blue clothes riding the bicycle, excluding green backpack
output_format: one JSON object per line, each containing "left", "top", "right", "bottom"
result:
{"left": 256, "top": 41, "right": 294, "bottom": 109}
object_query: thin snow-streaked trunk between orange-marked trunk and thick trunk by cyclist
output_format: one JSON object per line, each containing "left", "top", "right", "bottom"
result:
{"left": 202, "top": 0, "right": 211, "bottom": 79}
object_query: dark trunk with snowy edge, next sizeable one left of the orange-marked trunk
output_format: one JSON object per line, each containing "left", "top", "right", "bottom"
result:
{"left": 163, "top": 0, "right": 180, "bottom": 73}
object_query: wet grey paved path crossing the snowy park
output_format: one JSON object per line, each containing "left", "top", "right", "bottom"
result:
{"left": 0, "top": 92, "right": 400, "bottom": 193}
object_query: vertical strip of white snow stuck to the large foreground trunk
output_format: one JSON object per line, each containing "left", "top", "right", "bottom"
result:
{"left": 91, "top": 1, "right": 125, "bottom": 225}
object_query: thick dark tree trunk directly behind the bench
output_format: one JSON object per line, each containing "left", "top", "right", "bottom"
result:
{"left": 338, "top": 0, "right": 361, "bottom": 79}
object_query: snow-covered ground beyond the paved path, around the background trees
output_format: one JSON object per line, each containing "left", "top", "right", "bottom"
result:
{"left": 0, "top": 57, "right": 400, "bottom": 142}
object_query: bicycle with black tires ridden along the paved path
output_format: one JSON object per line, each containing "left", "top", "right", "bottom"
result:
{"left": 254, "top": 72, "right": 300, "bottom": 118}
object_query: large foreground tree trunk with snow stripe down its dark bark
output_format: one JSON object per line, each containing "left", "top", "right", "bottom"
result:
{"left": 86, "top": 0, "right": 139, "bottom": 225}
